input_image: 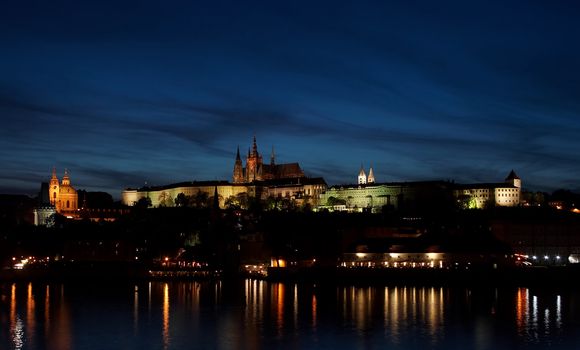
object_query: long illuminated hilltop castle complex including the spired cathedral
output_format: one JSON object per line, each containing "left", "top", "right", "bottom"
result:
{"left": 122, "top": 137, "right": 522, "bottom": 212}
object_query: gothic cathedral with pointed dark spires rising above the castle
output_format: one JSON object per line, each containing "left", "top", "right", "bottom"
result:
{"left": 233, "top": 136, "right": 304, "bottom": 184}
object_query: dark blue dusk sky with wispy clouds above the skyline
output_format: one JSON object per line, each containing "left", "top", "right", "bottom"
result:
{"left": 0, "top": 0, "right": 580, "bottom": 198}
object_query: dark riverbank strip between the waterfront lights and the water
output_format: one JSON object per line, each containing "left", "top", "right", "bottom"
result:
{"left": 0, "top": 263, "right": 580, "bottom": 287}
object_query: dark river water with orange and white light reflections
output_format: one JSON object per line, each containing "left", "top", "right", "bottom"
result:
{"left": 0, "top": 280, "right": 580, "bottom": 350}
